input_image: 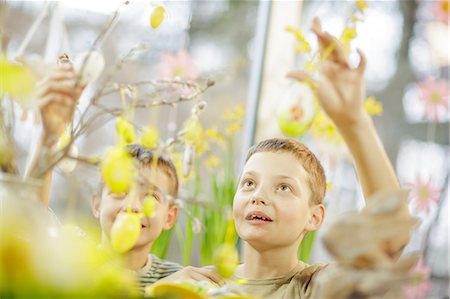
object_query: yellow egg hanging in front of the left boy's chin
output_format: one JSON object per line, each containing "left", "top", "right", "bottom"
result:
{"left": 111, "top": 213, "right": 141, "bottom": 253}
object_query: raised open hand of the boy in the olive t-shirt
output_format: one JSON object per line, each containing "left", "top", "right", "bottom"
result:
{"left": 287, "top": 18, "right": 366, "bottom": 128}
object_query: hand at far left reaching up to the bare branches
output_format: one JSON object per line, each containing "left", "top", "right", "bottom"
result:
{"left": 36, "top": 64, "right": 84, "bottom": 144}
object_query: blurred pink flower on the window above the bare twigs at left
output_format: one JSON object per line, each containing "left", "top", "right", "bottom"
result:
{"left": 158, "top": 50, "right": 198, "bottom": 80}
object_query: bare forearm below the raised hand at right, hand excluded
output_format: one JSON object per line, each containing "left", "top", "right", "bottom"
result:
{"left": 338, "top": 114, "right": 400, "bottom": 199}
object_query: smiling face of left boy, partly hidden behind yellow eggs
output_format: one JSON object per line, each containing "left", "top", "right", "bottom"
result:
{"left": 93, "top": 166, "right": 178, "bottom": 248}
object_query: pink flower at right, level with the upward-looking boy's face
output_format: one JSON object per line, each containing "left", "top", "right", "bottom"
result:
{"left": 409, "top": 176, "right": 441, "bottom": 214}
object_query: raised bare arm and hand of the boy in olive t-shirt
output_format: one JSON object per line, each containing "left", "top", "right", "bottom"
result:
{"left": 288, "top": 19, "right": 410, "bottom": 257}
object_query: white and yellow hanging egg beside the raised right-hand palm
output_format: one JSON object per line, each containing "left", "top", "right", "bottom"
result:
{"left": 277, "top": 82, "right": 317, "bottom": 137}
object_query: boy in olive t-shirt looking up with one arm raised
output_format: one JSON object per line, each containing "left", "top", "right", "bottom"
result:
{"left": 172, "top": 19, "right": 409, "bottom": 299}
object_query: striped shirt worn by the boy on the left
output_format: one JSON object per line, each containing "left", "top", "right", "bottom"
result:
{"left": 137, "top": 254, "right": 183, "bottom": 292}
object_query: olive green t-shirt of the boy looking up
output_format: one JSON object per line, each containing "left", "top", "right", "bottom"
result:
{"left": 231, "top": 262, "right": 326, "bottom": 299}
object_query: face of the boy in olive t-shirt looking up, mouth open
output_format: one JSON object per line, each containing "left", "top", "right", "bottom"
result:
{"left": 233, "top": 152, "right": 323, "bottom": 249}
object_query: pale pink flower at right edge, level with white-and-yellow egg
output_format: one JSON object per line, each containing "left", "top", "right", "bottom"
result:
{"left": 417, "top": 78, "right": 449, "bottom": 122}
